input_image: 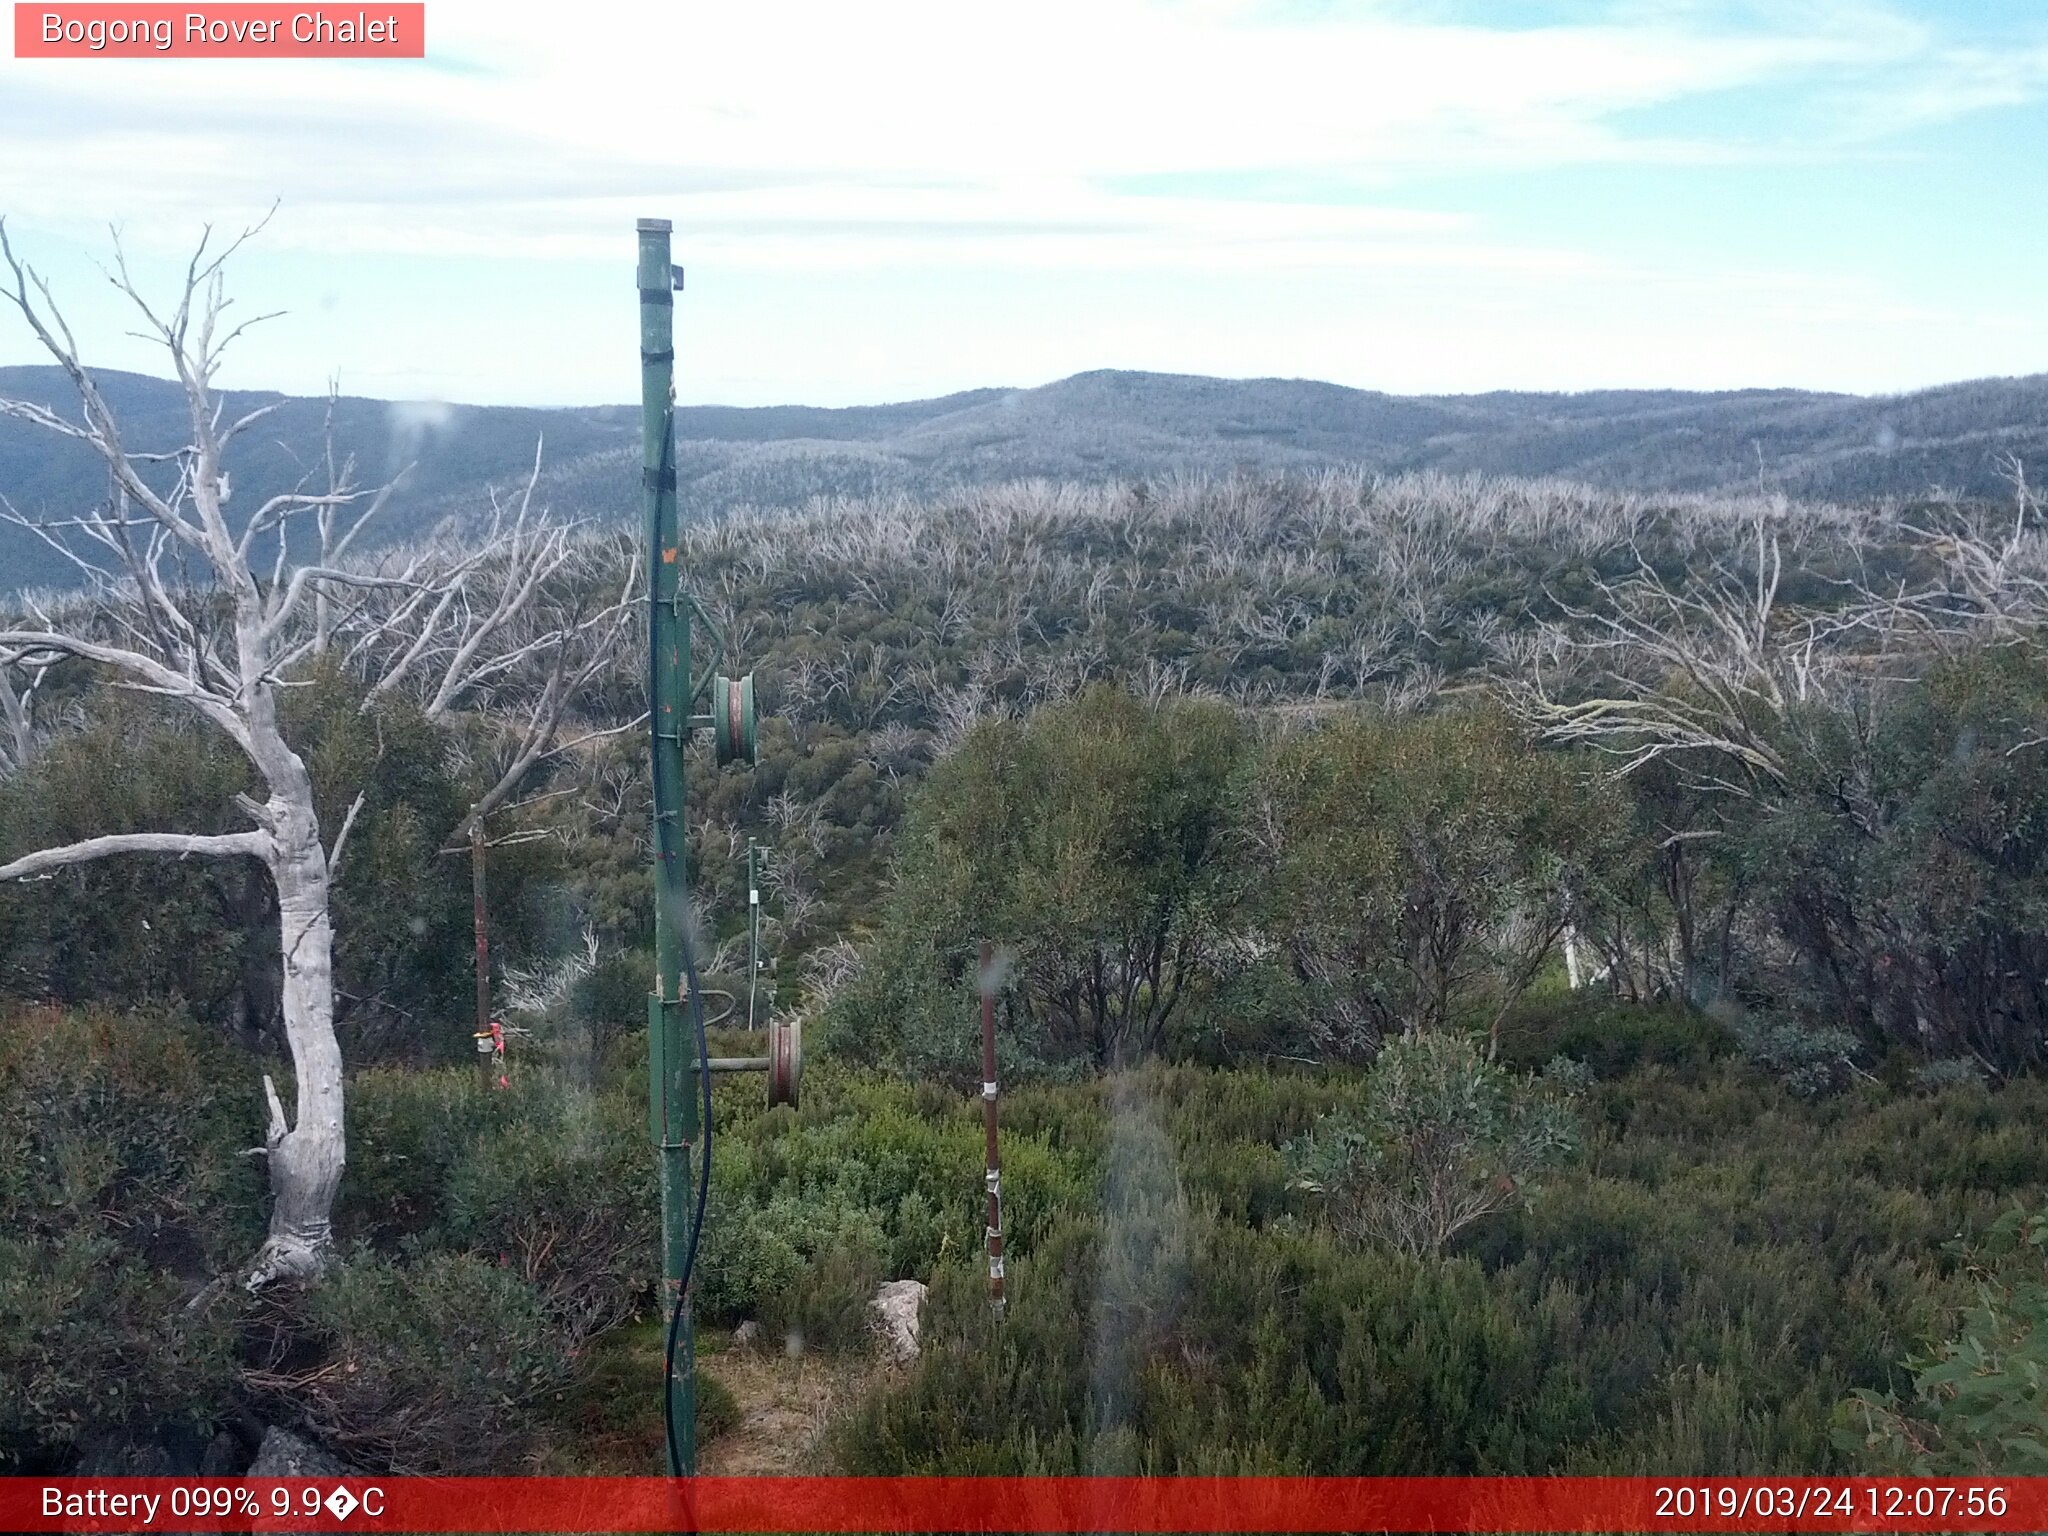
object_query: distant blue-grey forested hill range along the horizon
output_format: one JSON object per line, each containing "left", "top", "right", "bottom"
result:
{"left": 0, "top": 367, "right": 2048, "bottom": 590}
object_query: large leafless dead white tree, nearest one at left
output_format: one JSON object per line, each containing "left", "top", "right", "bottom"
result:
{"left": 0, "top": 225, "right": 385, "bottom": 1286}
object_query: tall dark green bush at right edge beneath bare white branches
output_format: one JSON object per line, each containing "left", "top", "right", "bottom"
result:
{"left": 1737, "top": 645, "right": 2048, "bottom": 1071}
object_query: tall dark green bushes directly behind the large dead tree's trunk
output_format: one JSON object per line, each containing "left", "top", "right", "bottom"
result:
{"left": 0, "top": 670, "right": 555, "bottom": 1063}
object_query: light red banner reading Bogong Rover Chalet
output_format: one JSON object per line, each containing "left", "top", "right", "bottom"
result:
{"left": 14, "top": 0, "right": 426, "bottom": 59}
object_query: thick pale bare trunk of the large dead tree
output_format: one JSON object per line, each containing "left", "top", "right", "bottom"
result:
{"left": 248, "top": 811, "right": 346, "bottom": 1290}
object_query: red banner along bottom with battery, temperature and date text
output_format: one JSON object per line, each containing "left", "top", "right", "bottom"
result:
{"left": 0, "top": 1477, "right": 2048, "bottom": 1532}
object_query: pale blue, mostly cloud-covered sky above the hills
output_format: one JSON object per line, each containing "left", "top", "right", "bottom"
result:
{"left": 0, "top": 0, "right": 2048, "bottom": 406}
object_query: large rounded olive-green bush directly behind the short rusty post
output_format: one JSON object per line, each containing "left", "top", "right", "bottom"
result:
{"left": 827, "top": 686, "right": 1249, "bottom": 1085}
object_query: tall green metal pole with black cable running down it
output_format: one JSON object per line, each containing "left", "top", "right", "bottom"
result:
{"left": 639, "top": 219, "right": 698, "bottom": 1475}
